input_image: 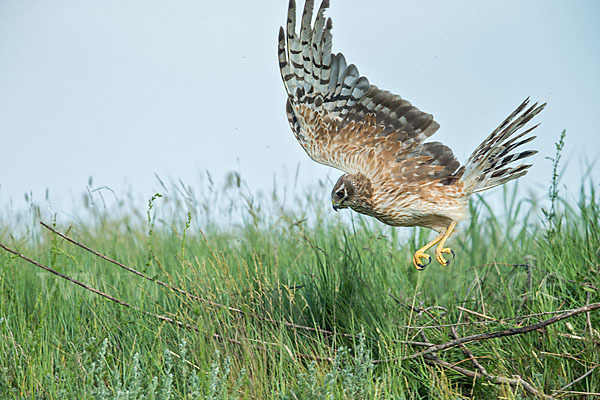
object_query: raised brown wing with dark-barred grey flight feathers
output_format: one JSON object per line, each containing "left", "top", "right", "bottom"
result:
{"left": 278, "top": 0, "right": 459, "bottom": 183}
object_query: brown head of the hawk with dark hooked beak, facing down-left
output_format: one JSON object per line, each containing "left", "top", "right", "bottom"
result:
{"left": 331, "top": 173, "right": 371, "bottom": 212}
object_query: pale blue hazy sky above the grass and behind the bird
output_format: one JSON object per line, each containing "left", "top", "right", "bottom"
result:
{"left": 0, "top": 0, "right": 600, "bottom": 216}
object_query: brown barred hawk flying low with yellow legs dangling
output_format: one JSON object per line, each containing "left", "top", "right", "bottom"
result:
{"left": 278, "top": 0, "right": 545, "bottom": 269}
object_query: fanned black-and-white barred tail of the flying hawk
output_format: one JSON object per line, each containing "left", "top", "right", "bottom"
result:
{"left": 461, "top": 98, "right": 546, "bottom": 193}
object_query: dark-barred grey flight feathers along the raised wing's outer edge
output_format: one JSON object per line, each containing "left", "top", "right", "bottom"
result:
{"left": 278, "top": 0, "right": 446, "bottom": 173}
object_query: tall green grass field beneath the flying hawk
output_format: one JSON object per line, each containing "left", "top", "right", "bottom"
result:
{"left": 0, "top": 139, "right": 600, "bottom": 399}
